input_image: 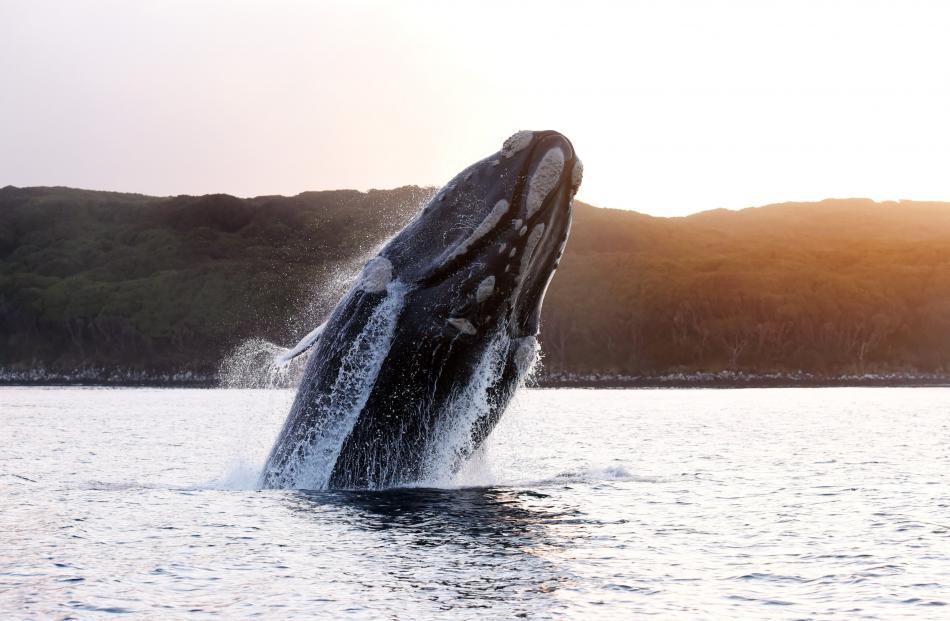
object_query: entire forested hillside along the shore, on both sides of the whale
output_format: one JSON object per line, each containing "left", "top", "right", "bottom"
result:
{"left": 0, "top": 187, "right": 950, "bottom": 376}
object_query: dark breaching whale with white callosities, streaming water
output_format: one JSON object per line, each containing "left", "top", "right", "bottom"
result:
{"left": 260, "top": 131, "right": 583, "bottom": 489}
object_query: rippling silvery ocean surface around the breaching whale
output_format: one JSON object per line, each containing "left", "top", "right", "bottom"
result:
{"left": 0, "top": 388, "right": 950, "bottom": 619}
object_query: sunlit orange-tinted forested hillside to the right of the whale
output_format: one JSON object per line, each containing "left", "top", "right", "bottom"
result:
{"left": 543, "top": 199, "right": 950, "bottom": 376}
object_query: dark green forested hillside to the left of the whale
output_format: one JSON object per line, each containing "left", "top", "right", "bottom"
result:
{"left": 0, "top": 187, "right": 431, "bottom": 373}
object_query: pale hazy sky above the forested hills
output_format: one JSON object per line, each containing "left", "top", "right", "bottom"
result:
{"left": 0, "top": 0, "right": 950, "bottom": 216}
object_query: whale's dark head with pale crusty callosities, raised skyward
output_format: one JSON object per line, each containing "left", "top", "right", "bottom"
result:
{"left": 376, "top": 131, "right": 583, "bottom": 339}
